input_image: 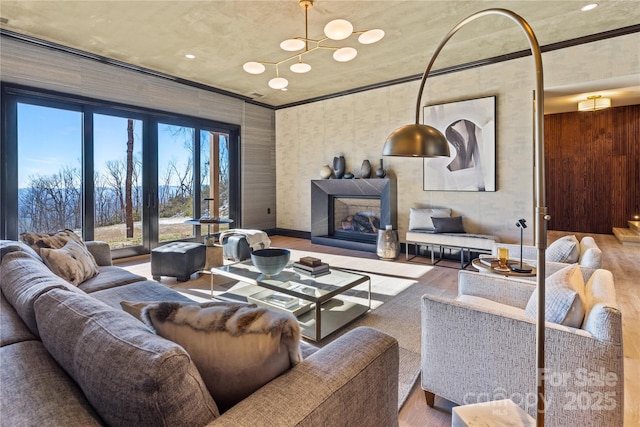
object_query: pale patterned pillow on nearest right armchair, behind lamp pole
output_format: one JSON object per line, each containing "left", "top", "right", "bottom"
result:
{"left": 525, "top": 264, "right": 585, "bottom": 328}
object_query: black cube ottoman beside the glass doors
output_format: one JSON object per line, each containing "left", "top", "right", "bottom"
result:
{"left": 151, "top": 242, "right": 207, "bottom": 282}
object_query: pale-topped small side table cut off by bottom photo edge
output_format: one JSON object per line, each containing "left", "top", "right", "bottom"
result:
{"left": 451, "top": 399, "right": 536, "bottom": 427}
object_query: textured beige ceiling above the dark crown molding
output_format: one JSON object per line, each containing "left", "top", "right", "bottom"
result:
{"left": 0, "top": 0, "right": 640, "bottom": 112}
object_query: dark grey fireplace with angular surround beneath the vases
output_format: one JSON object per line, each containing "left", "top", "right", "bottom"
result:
{"left": 311, "top": 179, "right": 397, "bottom": 252}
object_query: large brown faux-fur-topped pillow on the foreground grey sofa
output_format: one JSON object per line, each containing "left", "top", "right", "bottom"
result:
{"left": 121, "top": 301, "right": 302, "bottom": 412}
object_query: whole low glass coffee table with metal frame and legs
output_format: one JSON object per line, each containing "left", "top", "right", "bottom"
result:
{"left": 211, "top": 260, "right": 371, "bottom": 341}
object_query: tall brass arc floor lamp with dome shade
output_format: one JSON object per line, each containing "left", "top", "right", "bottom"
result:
{"left": 382, "top": 9, "right": 549, "bottom": 426}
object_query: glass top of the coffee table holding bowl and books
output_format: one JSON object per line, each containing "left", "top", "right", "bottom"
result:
{"left": 212, "top": 260, "right": 369, "bottom": 303}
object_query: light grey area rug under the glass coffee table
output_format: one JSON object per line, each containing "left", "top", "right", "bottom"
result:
{"left": 171, "top": 258, "right": 426, "bottom": 409}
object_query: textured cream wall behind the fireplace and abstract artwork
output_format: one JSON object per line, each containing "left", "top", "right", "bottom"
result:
{"left": 276, "top": 33, "right": 640, "bottom": 242}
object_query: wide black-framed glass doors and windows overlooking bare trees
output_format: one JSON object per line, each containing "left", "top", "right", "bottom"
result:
{"left": 0, "top": 85, "right": 241, "bottom": 256}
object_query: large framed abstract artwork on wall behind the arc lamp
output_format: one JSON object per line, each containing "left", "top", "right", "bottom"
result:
{"left": 423, "top": 96, "right": 496, "bottom": 191}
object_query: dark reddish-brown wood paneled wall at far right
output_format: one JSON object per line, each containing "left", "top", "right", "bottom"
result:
{"left": 544, "top": 105, "right": 640, "bottom": 234}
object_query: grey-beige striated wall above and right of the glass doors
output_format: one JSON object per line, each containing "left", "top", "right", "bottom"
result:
{"left": 0, "top": 37, "right": 276, "bottom": 229}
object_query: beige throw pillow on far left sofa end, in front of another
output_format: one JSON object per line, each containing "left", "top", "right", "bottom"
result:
{"left": 40, "top": 240, "right": 100, "bottom": 286}
